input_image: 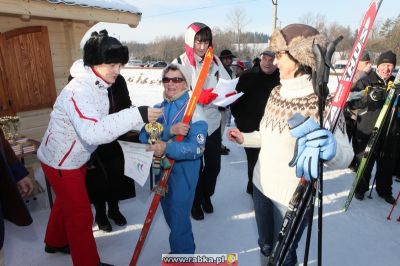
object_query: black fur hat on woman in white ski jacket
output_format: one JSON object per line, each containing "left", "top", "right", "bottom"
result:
{"left": 83, "top": 30, "right": 129, "bottom": 66}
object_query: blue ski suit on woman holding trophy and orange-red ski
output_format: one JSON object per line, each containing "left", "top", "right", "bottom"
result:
{"left": 139, "top": 92, "right": 207, "bottom": 254}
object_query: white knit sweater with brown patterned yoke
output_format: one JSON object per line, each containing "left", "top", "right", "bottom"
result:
{"left": 242, "top": 75, "right": 354, "bottom": 206}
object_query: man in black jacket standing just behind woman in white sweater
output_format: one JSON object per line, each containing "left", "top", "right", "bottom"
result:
{"left": 231, "top": 51, "right": 279, "bottom": 194}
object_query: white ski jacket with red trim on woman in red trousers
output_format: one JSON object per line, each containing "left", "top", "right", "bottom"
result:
{"left": 37, "top": 60, "right": 144, "bottom": 169}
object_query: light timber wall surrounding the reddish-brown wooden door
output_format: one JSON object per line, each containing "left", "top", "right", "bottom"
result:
{"left": 0, "top": 11, "right": 91, "bottom": 140}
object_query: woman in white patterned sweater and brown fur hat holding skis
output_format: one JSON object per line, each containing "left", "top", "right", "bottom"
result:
{"left": 228, "top": 24, "right": 353, "bottom": 265}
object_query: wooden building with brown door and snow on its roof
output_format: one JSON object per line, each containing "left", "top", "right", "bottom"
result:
{"left": 0, "top": 0, "right": 141, "bottom": 140}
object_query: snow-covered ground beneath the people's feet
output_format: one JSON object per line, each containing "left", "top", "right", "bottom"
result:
{"left": 4, "top": 69, "right": 400, "bottom": 266}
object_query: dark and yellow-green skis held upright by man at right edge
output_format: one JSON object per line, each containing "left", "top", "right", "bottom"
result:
{"left": 344, "top": 69, "right": 400, "bottom": 211}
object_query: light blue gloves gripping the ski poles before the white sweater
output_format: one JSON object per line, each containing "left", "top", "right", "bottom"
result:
{"left": 289, "top": 128, "right": 336, "bottom": 180}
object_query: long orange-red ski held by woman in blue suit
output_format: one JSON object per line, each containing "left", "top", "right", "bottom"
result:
{"left": 129, "top": 47, "right": 213, "bottom": 266}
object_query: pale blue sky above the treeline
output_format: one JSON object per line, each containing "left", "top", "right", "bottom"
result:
{"left": 84, "top": 0, "right": 400, "bottom": 43}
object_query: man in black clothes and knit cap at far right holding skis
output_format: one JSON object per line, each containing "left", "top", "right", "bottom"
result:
{"left": 349, "top": 51, "right": 399, "bottom": 204}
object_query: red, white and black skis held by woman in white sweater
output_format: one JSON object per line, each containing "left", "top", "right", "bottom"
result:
{"left": 268, "top": 0, "right": 382, "bottom": 265}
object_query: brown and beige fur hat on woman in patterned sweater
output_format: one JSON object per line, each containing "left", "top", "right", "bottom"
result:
{"left": 270, "top": 24, "right": 328, "bottom": 69}
